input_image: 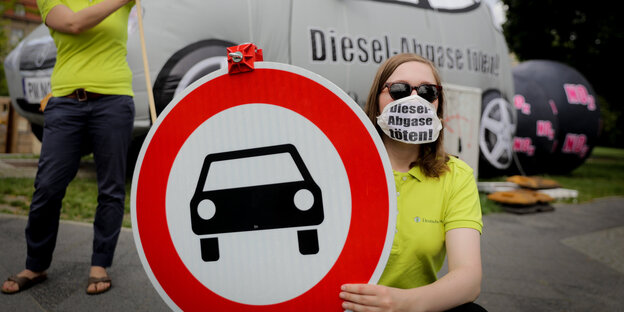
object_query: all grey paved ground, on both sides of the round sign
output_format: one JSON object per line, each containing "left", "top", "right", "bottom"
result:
{"left": 0, "top": 158, "right": 624, "bottom": 312}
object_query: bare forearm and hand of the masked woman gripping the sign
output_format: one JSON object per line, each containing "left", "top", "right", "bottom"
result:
{"left": 340, "top": 228, "right": 481, "bottom": 312}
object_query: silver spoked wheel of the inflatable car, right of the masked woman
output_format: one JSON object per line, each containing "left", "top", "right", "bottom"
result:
{"left": 479, "top": 90, "right": 516, "bottom": 177}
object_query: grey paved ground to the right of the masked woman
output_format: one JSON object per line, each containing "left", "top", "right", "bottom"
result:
{"left": 478, "top": 197, "right": 624, "bottom": 312}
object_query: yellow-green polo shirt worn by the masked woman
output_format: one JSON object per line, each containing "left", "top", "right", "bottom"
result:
{"left": 379, "top": 156, "right": 483, "bottom": 289}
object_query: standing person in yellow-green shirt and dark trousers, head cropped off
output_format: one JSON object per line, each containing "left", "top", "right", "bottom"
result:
{"left": 2, "top": 0, "right": 135, "bottom": 294}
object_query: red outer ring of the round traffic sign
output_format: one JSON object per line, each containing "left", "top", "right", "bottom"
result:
{"left": 134, "top": 68, "right": 389, "bottom": 311}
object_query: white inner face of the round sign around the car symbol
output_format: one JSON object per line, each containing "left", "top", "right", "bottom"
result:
{"left": 166, "top": 104, "right": 351, "bottom": 305}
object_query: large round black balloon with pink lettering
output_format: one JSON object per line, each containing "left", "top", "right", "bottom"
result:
{"left": 513, "top": 60, "right": 600, "bottom": 174}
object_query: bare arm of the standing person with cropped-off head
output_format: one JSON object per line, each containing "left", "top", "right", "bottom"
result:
{"left": 45, "top": 0, "right": 132, "bottom": 34}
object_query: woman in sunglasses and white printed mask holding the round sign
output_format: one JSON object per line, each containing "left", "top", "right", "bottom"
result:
{"left": 340, "top": 54, "right": 484, "bottom": 311}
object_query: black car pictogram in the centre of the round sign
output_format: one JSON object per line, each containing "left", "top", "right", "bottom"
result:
{"left": 190, "top": 144, "right": 324, "bottom": 261}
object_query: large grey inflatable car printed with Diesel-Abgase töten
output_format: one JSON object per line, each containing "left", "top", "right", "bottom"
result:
{"left": 5, "top": 0, "right": 515, "bottom": 176}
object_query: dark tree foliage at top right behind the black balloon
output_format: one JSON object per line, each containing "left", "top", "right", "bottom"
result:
{"left": 502, "top": 0, "right": 624, "bottom": 147}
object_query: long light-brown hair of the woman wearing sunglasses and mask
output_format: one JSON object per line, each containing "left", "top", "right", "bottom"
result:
{"left": 364, "top": 53, "right": 449, "bottom": 178}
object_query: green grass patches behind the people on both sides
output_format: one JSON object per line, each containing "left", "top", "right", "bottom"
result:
{"left": 0, "top": 147, "right": 624, "bottom": 227}
